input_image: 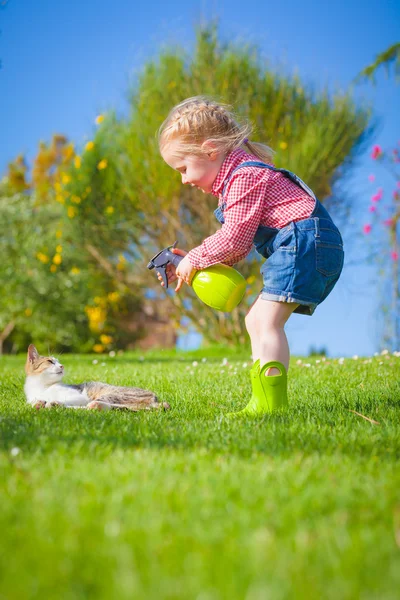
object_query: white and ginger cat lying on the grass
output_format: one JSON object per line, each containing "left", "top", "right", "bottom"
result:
{"left": 24, "top": 344, "right": 170, "bottom": 411}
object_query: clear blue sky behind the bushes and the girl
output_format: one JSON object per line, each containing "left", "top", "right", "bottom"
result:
{"left": 0, "top": 0, "right": 400, "bottom": 356}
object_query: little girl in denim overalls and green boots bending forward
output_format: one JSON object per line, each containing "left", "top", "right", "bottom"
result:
{"left": 159, "top": 97, "right": 344, "bottom": 415}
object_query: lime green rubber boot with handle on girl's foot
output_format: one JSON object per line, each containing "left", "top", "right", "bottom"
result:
{"left": 226, "top": 360, "right": 288, "bottom": 418}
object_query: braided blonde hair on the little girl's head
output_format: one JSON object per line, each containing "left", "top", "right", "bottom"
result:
{"left": 158, "top": 96, "right": 273, "bottom": 162}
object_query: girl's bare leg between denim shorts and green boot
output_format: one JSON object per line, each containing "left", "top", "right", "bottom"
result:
{"left": 246, "top": 296, "right": 299, "bottom": 375}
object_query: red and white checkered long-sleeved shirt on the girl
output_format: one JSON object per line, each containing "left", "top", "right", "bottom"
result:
{"left": 188, "top": 150, "right": 315, "bottom": 269}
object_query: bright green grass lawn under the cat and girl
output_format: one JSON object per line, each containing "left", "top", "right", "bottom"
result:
{"left": 0, "top": 350, "right": 400, "bottom": 600}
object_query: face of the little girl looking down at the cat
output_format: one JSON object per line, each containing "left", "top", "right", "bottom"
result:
{"left": 162, "top": 141, "right": 226, "bottom": 194}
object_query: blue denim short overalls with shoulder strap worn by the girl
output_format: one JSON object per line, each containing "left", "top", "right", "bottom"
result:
{"left": 214, "top": 161, "right": 344, "bottom": 315}
